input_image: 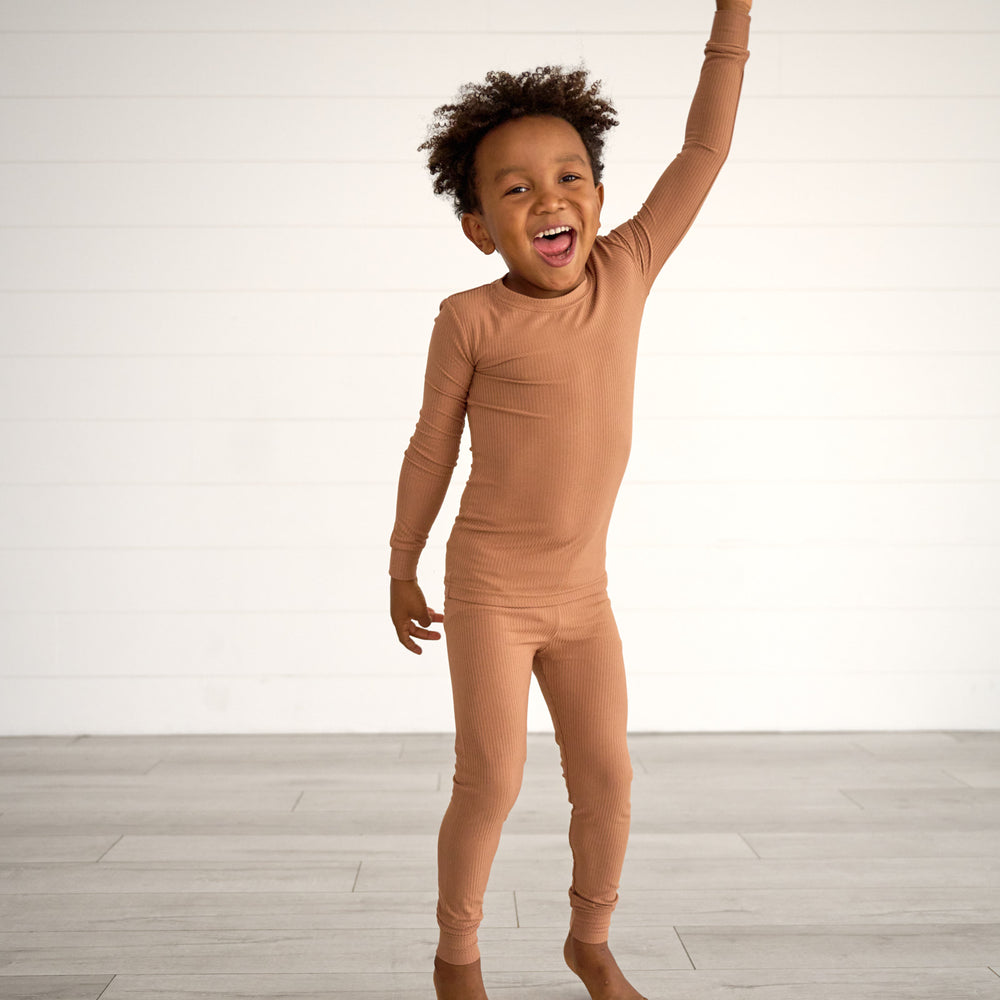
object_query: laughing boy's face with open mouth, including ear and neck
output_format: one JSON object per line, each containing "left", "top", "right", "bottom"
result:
{"left": 462, "top": 115, "right": 604, "bottom": 298}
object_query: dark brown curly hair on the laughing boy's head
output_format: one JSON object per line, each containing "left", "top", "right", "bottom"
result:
{"left": 418, "top": 66, "right": 618, "bottom": 217}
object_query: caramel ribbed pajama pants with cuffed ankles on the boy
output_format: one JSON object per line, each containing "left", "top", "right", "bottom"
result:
{"left": 437, "top": 593, "right": 632, "bottom": 965}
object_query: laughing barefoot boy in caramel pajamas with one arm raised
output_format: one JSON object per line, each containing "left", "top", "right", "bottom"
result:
{"left": 389, "top": 0, "right": 750, "bottom": 1000}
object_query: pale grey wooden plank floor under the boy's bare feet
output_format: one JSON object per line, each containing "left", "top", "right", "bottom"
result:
{"left": 0, "top": 732, "right": 1000, "bottom": 1000}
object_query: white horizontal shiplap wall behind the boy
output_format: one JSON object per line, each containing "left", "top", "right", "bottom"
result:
{"left": 0, "top": 0, "right": 1000, "bottom": 733}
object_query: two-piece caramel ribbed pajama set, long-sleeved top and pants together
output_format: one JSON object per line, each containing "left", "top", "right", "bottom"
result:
{"left": 389, "top": 5, "right": 750, "bottom": 965}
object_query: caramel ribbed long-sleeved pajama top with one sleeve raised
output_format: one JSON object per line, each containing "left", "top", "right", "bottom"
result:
{"left": 389, "top": 12, "right": 750, "bottom": 607}
